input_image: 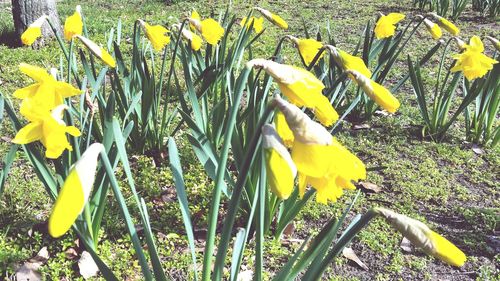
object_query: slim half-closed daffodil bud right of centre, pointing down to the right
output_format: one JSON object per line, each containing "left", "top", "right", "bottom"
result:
{"left": 347, "top": 70, "right": 400, "bottom": 113}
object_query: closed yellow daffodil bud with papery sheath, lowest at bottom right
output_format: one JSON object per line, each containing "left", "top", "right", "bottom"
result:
{"left": 375, "top": 208, "right": 467, "bottom": 267}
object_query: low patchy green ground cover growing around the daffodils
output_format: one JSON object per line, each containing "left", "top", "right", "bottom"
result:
{"left": 0, "top": 0, "right": 500, "bottom": 280}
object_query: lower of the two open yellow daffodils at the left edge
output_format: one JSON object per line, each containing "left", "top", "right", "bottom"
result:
{"left": 12, "top": 104, "right": 81, "bottom": 159}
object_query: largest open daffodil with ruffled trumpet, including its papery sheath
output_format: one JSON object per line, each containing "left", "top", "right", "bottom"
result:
{"left": 273, "top": 97, "right": 366, "bottom": 204}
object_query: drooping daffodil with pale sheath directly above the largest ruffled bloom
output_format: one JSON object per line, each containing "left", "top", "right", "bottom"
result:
{"left": 248, "top": 59, "right": 339, "bottom": 126}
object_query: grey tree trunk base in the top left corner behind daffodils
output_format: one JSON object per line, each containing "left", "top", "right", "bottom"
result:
{"left": 12, "top": 0, "right": 62, "bottom": 47}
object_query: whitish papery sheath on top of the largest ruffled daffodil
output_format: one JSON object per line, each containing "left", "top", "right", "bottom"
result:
{"left": 273, "top": 96, "right": 332, "bottom": 145}
